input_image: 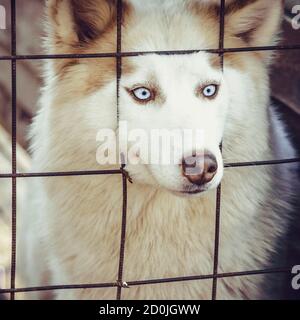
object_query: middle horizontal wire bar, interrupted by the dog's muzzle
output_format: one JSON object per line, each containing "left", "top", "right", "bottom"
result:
{"left": 0, "top": 158, "right": 300, "bottom": 179}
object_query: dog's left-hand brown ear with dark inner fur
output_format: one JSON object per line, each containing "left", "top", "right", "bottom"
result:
{"left": 47, "top": 0, "right": 117, "bottom": 47}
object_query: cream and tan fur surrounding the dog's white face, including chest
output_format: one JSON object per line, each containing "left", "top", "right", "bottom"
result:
{"left": 17, "top": 0, "right": 287, "bottom": 299}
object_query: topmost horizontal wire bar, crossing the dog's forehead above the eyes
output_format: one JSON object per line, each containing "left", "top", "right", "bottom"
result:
{"left": 0, "top": 44, "right": 300, "bottom": 61}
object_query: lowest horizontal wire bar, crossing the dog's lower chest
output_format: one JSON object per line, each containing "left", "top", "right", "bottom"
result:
{"left": 0, "top": 268, "right": 291, "bottom": 294}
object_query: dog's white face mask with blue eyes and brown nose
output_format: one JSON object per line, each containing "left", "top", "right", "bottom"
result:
{"left": 120, "top": 52, "right": 229, "bottom": 194}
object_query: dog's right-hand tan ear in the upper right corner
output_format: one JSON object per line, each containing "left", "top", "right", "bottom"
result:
{"left": 225, "top": 0, "right": 283, "bottom": 47}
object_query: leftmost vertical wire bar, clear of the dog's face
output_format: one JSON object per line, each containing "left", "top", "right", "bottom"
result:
{"left": 10, "top": 0, "right": 17, "bottom": 300}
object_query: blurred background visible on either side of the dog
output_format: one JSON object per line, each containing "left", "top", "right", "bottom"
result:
{"left": 0, "top": 0, "right": 300, "bottom": 298}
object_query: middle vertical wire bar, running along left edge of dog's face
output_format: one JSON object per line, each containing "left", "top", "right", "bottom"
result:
{"left": 116, "top": 0, "right": 128, "bottom": 300}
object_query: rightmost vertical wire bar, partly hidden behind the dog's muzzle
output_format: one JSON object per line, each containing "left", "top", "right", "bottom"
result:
{"left": 212, "top": 0, "right": 225, "bottom": 300}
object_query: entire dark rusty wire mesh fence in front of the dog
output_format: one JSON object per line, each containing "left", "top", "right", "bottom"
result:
{"left": 0, "top": 0, "right": 300, "bottom": 300}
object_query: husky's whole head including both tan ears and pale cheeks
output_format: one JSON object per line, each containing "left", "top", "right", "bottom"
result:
{"left": 42, "top": 0, "right": 281, "bottom": 195}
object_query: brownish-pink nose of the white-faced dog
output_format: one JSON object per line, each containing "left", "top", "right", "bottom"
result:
{"left": 182, "top": 152, "right": 218, "bottom": 186}
